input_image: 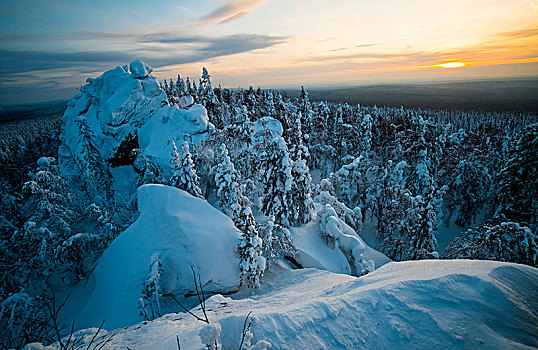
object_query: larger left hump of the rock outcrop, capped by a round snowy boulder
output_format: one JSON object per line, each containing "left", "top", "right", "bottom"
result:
{"left": 61, "top": 61, "right": 168, "bottom": 164}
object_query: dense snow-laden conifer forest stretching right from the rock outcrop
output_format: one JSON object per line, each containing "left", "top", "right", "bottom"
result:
{"left": 162, "top": 69, "right": 538, "bottom": 265}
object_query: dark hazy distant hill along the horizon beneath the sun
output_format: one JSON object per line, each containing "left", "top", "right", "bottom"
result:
{"left": 285, "top": 78, "right": 538, "bottom": 113}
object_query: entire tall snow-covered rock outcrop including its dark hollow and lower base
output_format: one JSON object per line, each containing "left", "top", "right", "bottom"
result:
{"left": 58, "top": 60, "right": 212, "bottom": 205}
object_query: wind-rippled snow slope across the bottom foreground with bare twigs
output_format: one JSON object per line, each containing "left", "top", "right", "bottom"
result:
{"left": 51, "top": 260, "right": 538, "bottom": 350}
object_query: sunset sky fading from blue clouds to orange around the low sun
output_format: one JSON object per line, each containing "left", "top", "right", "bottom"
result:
{"left": 0, "top": 0, "right": 538, "bottom": 104}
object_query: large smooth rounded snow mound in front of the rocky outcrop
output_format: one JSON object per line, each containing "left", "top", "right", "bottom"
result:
{"left": 75, "top": 184, "right": 240, "bottom": 329}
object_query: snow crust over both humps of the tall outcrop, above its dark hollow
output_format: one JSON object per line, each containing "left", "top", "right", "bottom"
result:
{"left": 59, "top": 60, "right": 211, "bottom": 185}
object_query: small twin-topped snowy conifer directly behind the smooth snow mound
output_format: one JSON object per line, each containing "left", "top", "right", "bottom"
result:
{"left": 169, "top": 141, "right": 204, "bottom": 198}
